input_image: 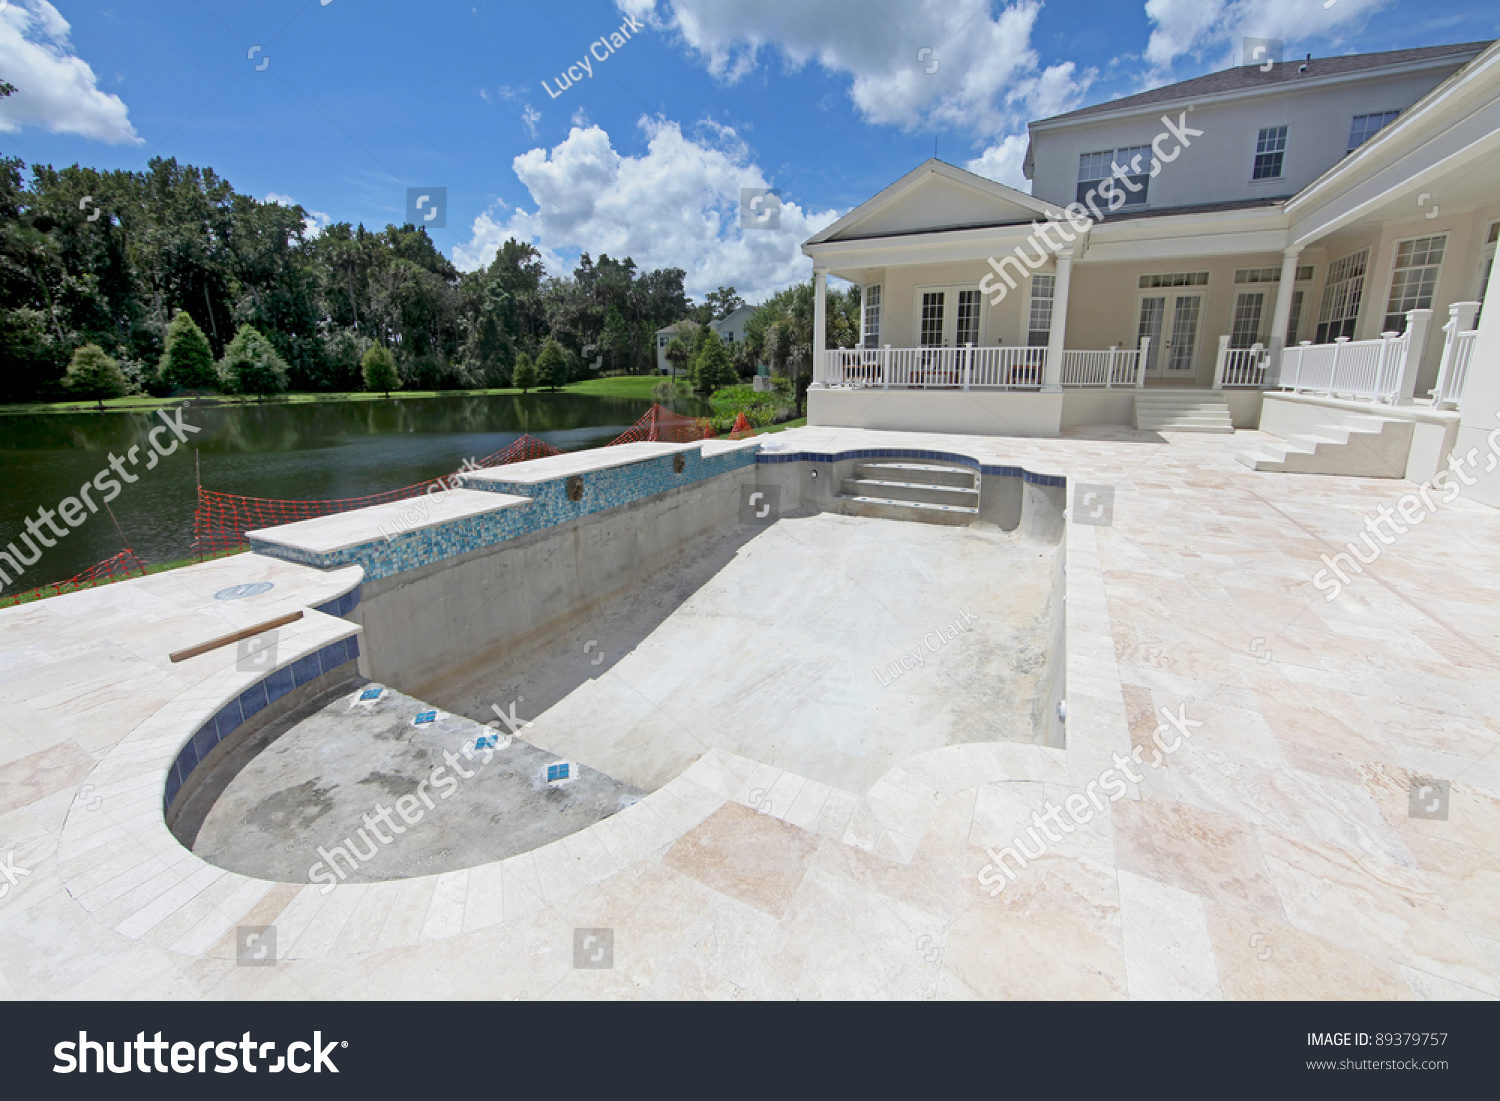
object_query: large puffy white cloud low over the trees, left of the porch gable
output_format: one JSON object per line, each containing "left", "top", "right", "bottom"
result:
{"left": 453, "top": 119, "right": 839, "bottom": 302}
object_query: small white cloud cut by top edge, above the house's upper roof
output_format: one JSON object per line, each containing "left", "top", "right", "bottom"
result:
{"left": 1146, "top": 0, "right": 1392, "bottom": 69}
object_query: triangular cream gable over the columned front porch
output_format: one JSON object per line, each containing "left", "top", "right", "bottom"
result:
{"left": 803, "top": 158, "right": 1062, "bottom": 249}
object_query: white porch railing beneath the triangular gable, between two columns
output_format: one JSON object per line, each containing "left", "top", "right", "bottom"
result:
{"left": 822, "top": 345, "right": 1047, "bottom": 390}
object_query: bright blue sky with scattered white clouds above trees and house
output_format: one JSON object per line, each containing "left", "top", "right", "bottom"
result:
{"left": 0, "top": 0, "right": 1500, "bottom": 300}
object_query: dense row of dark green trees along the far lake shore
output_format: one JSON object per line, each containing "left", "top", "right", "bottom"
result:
{"left": 0, "top": 144, "right": 858, "bottom": 402}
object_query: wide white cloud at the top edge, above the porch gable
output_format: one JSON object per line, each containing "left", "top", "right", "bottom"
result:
{"left": 617, "top": 0, "right": 1094, "bottom": 135}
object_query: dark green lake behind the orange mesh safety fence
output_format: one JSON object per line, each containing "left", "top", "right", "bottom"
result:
{"left": 0, "top": 393, "right": 708, "bottom": 594}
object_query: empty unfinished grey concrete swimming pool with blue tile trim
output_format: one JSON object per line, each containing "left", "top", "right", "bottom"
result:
{"left": 168, "top": 446, "right": 1062, "bottom": 882}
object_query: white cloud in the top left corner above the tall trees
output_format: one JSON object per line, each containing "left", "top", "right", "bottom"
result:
{"left": 0, "top": 0, "right": 141, "bottom": 144}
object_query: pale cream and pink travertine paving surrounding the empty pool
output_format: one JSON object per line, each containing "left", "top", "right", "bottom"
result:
{"left": 0, "top": 429, "right": 1500, "bottom": 999}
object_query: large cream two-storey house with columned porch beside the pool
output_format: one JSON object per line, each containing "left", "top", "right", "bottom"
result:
{"left": 803, "top": 44, "right": 1500, "bottom": 462}
